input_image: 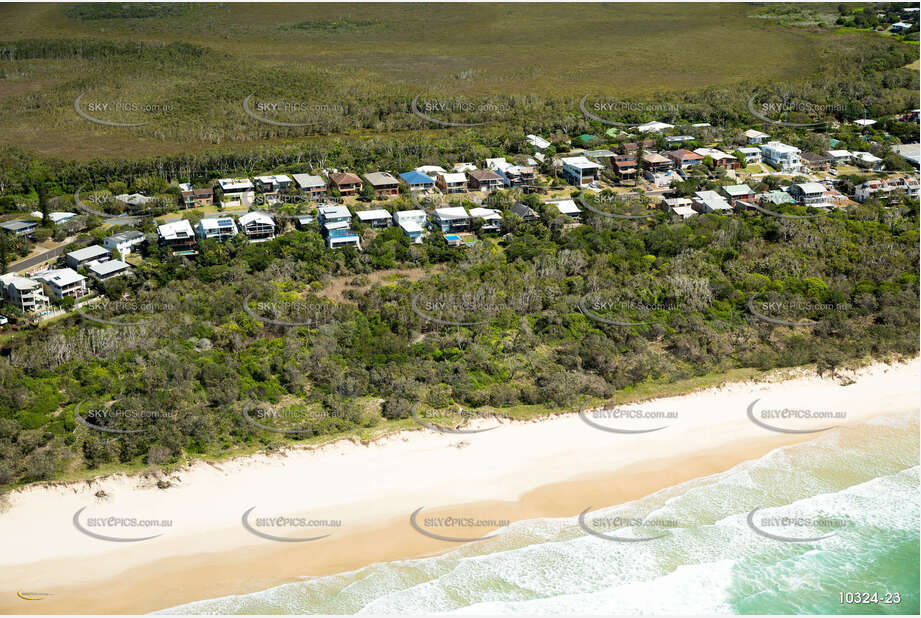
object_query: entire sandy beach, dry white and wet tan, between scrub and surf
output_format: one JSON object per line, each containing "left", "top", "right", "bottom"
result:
{"left": 0, "top": 359, "right": 921, "bottom": 613}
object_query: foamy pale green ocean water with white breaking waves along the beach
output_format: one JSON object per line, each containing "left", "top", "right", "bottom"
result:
{"left": 161, "top": 416, "right": 919, "bottom": 615}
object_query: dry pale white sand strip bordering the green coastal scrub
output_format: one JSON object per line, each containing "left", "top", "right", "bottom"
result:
{"left": 0, "top": 359, "right": 921, "bottom": 609}
